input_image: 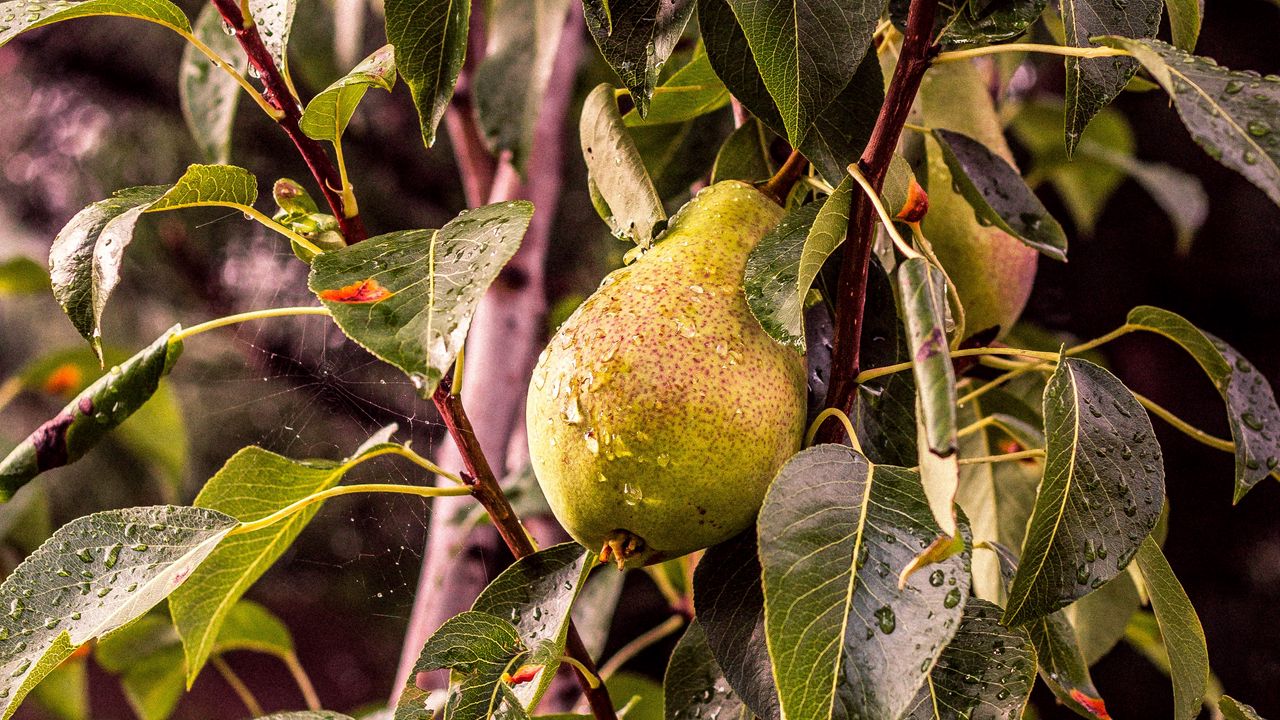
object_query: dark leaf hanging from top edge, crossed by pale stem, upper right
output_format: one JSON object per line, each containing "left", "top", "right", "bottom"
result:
{"left": 1060, "top": 0, "right": 1165, "bottom": 155}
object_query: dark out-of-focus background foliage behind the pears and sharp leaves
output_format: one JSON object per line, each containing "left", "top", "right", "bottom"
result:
{"left": 0, "top": 0, "right": 1280, "bottom": 719}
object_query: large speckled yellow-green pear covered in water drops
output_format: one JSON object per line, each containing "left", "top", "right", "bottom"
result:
{"left": 526, "top": 181, "right": 805, "bottom": 566}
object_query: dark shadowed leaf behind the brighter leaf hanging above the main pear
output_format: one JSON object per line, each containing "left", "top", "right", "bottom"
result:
{"left": 698, "top": 0, "right": 884, "bottom": 184}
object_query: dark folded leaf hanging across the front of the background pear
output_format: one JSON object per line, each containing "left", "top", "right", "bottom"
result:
{"left": 933, "top": 129, "right": 1066, "bottom": 261}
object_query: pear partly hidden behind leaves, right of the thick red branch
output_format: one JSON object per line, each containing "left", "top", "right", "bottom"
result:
{"left": 920, "top": 61, "right": 1037, "bottom": 336}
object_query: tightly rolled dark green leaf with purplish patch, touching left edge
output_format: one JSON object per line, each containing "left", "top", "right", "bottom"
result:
{"left": 0, "top": 325, "right": 182, "bottom": 501}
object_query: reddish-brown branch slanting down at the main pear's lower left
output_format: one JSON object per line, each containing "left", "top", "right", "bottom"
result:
{"left": 431, "top": 380, "right": 617, "bottom": 720}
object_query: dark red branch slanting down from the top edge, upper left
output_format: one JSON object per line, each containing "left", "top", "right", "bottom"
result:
{"left": 204, "top": 0, "right": 367, "bottom": 243}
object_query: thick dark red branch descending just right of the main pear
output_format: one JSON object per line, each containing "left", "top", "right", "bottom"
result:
{"left": 818, "top": 0, "right": 938, "bottom": 442}
